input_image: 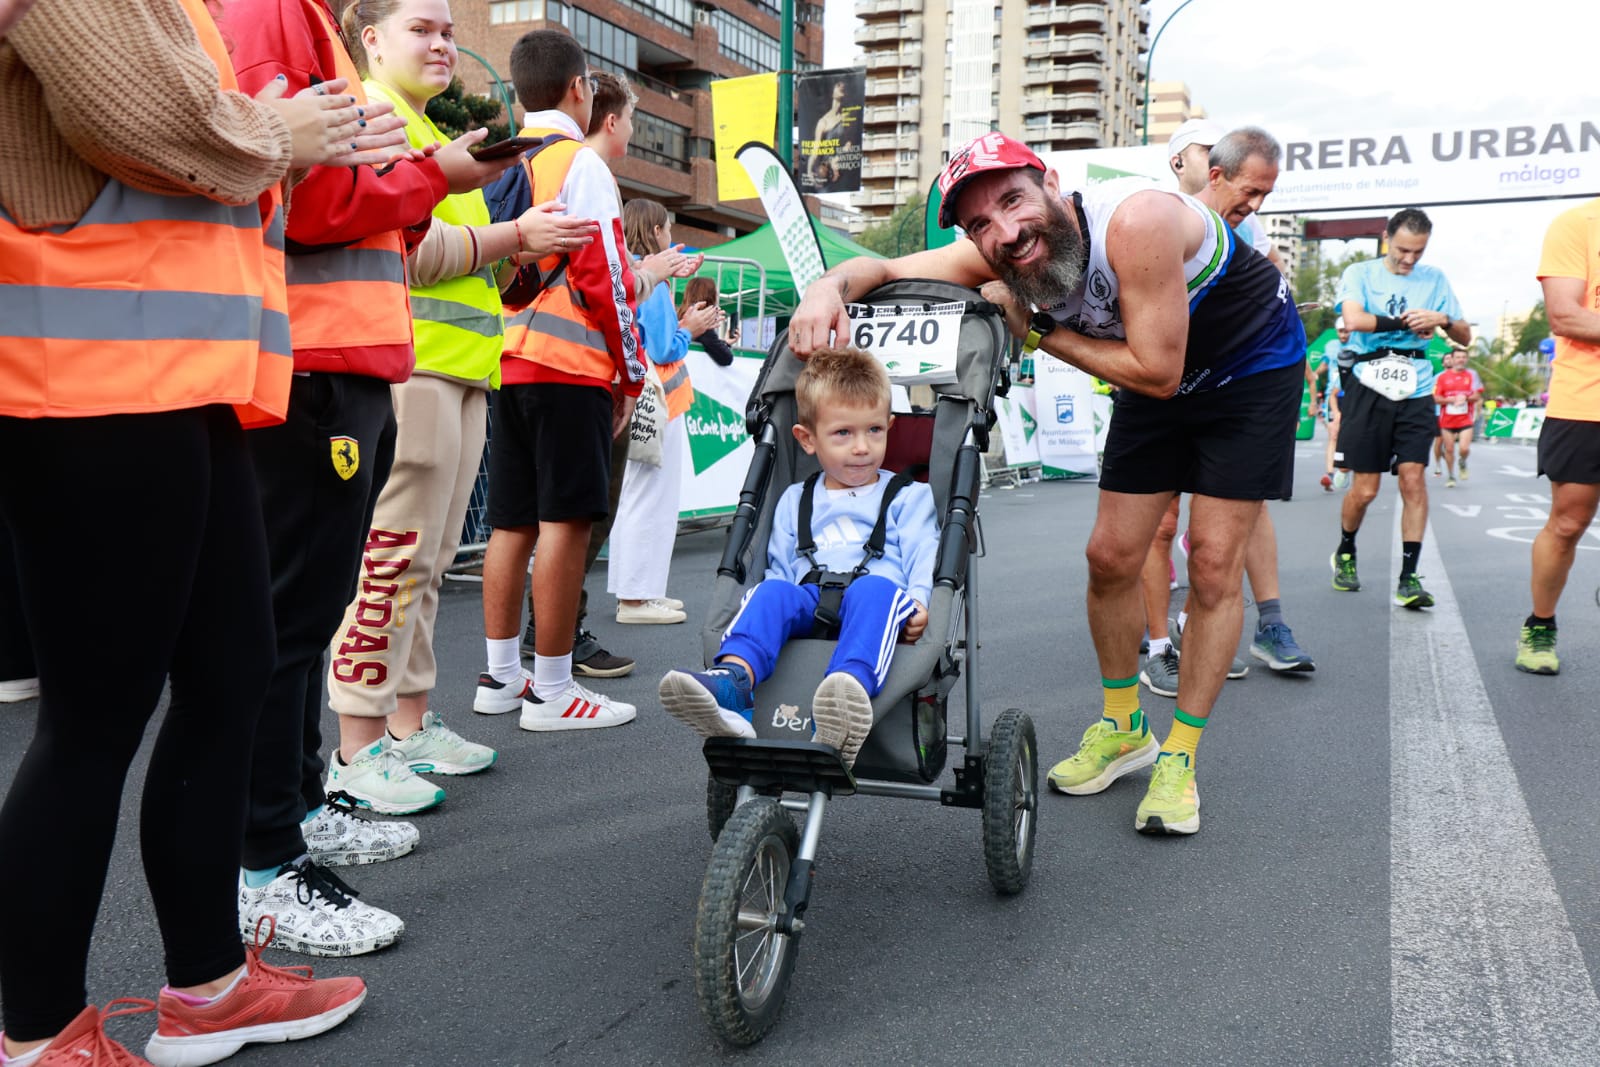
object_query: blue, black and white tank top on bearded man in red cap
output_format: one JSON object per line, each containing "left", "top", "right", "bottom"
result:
{"left": 1045, "top": 178, "right": 1306, "bottom": 395}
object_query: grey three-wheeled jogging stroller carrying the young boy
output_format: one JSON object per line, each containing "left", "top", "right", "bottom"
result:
{"left": 694, "top": 280, "right": 1038, "bottom": 1045}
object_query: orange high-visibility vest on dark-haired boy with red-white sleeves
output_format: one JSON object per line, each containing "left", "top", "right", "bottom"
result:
{"left": 506, "top": 128, "right": 616, "bottom": 382}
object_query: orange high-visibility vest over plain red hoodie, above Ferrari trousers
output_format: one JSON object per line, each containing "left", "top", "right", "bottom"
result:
{"left": 286, "top": 0, "right": 411, "bottom": 349}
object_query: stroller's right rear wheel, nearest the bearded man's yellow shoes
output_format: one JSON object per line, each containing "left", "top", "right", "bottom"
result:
{"left": 984, "top": 707, "right": 1038, "bottom": 896}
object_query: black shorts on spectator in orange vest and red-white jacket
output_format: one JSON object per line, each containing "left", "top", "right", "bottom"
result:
{"left": 485, "top": 382, "right": 611, "bottom": 528}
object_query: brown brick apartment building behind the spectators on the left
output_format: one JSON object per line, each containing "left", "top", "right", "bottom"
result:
{"left": 451, "top": 0, "right": 822, "bottom": 246}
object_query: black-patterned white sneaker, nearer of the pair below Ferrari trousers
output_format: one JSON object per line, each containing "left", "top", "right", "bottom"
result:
{"left": 238, "top": 859, "right": 405, "bottom": 957}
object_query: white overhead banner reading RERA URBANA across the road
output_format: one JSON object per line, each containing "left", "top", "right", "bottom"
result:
{"left": 1043, "top": 118, "right": 1600, "bottom": 214}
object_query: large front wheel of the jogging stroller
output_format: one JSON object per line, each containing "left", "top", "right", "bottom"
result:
{"left": 694, "top": 798, "right": 800, "bottom": 1045}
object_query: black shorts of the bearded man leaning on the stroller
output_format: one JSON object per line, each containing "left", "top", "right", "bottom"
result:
{"left": 1101, "top": 363, "right": 1306, "bottom": 501}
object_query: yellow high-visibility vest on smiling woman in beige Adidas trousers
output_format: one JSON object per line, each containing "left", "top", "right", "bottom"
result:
{"left": 366, "top": 80, "right": 506, "bottom": 386}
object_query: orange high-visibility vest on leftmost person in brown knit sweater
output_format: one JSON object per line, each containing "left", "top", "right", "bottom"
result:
{"left": 0, "top": 0, "right": 294, "bottom": 426}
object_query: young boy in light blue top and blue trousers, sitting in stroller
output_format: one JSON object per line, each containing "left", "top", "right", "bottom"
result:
{"left": 659, "top": 349, "right": 939, "bottom": 766}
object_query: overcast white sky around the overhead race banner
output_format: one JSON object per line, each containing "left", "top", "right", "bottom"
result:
{"left": 826, "top": 0, "right": 1600, "bottom": 333}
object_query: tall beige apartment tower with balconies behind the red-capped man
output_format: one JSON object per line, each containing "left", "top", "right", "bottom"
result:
{"left": 856, "top": 0, "right": 1150, "bottom": 219}
